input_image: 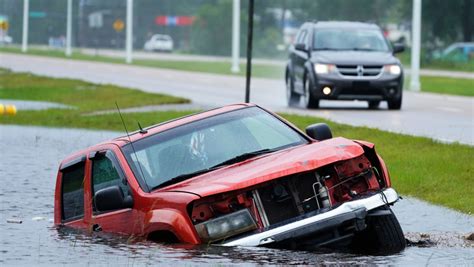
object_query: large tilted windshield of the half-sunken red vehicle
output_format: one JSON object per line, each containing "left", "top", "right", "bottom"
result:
{"left": 123, "top": 107, "right": 308, "bottom": 190}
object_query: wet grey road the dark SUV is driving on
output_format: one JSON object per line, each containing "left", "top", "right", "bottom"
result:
{"left": 0, "top": 53, "right": 474, "bottom": 145}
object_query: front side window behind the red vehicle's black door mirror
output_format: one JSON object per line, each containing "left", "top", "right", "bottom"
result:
{"left": 91, "top": 151, "right": 129, "bottom": 211}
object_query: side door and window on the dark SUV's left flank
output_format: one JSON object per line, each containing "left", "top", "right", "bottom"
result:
{"left": 291, "top": 27, "right": 310, "bottom": 93}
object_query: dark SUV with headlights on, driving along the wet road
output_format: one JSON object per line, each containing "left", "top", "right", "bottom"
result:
{"left": 285, "top": 21, "right": 404, "bottom": 109}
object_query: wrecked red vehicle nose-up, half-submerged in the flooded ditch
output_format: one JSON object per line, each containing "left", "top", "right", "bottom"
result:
{"left": 54, "top": 104, "right": 405, "bottom": 253}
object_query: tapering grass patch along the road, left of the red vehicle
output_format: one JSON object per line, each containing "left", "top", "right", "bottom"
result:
{"left": 0, "top": 69, "right": 189, "bottom": 112}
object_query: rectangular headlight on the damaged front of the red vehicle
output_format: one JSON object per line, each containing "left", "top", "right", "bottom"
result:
{"left": 195, "top": 209, "right": 257, "bottom": 242}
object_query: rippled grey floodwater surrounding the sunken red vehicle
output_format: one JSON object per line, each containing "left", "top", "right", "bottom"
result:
{"left": 0, "top": 125, "right": 474, "bottom": 266}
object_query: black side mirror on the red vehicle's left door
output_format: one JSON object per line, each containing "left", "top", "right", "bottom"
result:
{"left": 94, "top": 185, "right": 133, "bottom": 214}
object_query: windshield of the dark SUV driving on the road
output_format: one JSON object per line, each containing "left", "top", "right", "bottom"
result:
{"left": 313, "top": 29, "right": 390, "bottom": 52}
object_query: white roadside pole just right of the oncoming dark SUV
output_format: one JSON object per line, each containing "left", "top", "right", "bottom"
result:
{"left": 410, "top": 0, "right": 421, "bottom": 91}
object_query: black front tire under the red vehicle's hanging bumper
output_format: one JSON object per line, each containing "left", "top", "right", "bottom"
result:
{"left": 352, "top": 207, "right": 406, "bottom": 255}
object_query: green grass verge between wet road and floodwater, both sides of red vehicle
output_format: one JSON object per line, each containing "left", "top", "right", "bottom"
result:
{"left": 0, "top": 70, "right": 474, "bottom": 214}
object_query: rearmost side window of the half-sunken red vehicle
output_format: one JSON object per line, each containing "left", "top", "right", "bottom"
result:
{"left": 61, "top": 162, "right": 84, "bottom": 221}
